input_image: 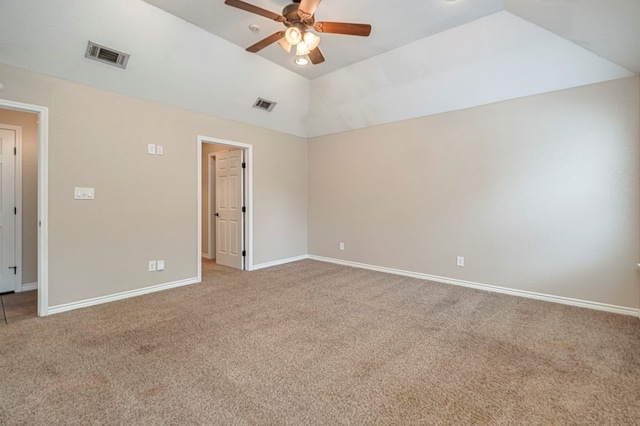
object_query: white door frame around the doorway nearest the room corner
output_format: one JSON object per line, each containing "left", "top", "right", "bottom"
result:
{"left": 196, "top": 135, "right": 253, "bottom": 281}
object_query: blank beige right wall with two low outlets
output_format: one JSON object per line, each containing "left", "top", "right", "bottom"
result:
{"left": 308, "top": 77, "right": 640, "bottom": 308}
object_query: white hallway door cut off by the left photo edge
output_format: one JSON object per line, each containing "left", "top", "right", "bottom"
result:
{"left": 0, "top": 126, "right": 17, "bottom": 293}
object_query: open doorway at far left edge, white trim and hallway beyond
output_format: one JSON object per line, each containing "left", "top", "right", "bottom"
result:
{"left": 0, "top": 99, "right": 48, "bottom": 314}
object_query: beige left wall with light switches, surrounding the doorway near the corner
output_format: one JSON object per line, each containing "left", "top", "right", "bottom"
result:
{"left": 0, "top": 64, "right": 307, "bottom": 306}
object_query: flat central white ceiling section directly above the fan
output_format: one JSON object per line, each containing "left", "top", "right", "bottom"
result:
{"left": 145, "top": 0, "right": 503, "bottom": 79}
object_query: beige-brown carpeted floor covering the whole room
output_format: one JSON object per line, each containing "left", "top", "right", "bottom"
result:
{"left": 0, "top": 260, "right": 640, "bottom": 425}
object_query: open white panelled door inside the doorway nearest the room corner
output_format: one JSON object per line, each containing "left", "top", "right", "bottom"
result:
{"left": 215, "top": 149, "right": 244, "bottom": 269}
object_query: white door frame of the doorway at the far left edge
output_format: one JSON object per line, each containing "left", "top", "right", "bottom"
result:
{"left": 0, "top": 99, "right": 49, "bottom": 317}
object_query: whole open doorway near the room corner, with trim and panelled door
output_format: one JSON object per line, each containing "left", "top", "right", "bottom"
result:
{"left": 198, "top": 136, "right": 253, "bottom": 280}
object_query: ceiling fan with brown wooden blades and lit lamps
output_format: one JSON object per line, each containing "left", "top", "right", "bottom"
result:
{"left": 224, "top": 0, "right": 371, "bottom": 64}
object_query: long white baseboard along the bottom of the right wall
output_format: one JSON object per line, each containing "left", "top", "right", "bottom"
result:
{"left": 308, "top": 255, "right": 640, "bottom": 317}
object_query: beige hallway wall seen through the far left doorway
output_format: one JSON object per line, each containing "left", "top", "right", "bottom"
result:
{"left": 0, "top": 108, "right": 38, "bottom": 284}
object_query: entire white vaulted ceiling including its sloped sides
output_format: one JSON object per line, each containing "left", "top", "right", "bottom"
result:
{"left": 0, "top": 0, "right": 640, "bottom": 136}
